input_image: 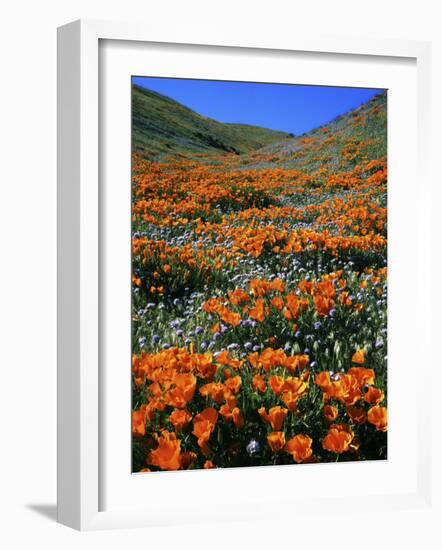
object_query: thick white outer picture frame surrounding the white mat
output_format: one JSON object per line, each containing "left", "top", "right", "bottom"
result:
{"left": 58, "top": 21, "right": 431, "bottom": 530}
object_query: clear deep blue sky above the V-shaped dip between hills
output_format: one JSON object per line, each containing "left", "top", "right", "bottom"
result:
{"left": 133, "top": 77, "right": 382, "bottom": 135}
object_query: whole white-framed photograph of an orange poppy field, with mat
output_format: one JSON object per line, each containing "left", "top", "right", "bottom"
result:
{"left": 58, "top": 21, "right": 431, "bottom": 530}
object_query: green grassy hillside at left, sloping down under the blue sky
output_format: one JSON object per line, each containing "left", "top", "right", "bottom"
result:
{"left": 132, "top": 86, "right": 293, "bottom": 160}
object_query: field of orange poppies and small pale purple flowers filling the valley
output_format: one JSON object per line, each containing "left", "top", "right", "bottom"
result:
{"left": 132, "top": 84, "right": 387, "bottom": 472}
